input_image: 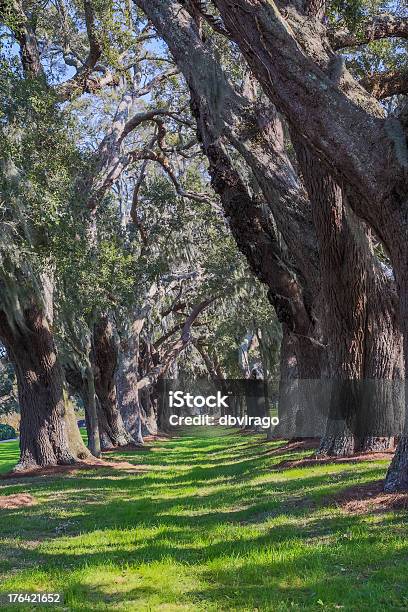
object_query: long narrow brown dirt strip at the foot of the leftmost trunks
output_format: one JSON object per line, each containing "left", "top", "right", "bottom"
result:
{"left": 0, "top": 457, "right": 147, "bottom": 480}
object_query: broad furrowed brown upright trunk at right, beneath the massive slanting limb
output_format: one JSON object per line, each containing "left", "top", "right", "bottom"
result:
{"left": 292, "top": 137, "right": 401, "bottom": 455}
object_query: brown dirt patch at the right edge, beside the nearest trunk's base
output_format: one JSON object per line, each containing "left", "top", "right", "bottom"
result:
{"left": 326, "top": 480, "right": 408, "bottom": 514}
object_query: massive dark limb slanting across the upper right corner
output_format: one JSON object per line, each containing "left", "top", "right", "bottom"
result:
{"left": 212, "top": 0, "right": 408, "bottom": 224}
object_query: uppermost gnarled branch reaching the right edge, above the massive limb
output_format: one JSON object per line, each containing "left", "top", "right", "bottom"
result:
{"left": 328, "top": 14, "right": 408, "bottom": 49}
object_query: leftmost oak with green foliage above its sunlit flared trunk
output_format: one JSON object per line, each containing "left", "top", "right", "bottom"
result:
{"left": 0, "top": 59, "right": 88, "bottom": 468}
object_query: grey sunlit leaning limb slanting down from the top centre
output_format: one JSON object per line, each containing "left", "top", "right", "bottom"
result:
{"left": 138, "top": 0, "right": 318, "bottom": 296}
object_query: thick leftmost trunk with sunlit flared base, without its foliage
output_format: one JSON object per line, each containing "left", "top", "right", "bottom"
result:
{"left": 0, "top": 305, "right": 90, "bottom": 470}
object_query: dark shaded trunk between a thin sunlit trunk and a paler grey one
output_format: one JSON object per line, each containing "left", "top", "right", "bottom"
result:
{"left": 92, "top": 316, "right": 133, "bottom": 449}
